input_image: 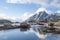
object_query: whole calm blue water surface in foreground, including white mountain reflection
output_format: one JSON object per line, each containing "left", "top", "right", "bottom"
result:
{"left": 0, "top": 27, "right": 60, "bottom": 40}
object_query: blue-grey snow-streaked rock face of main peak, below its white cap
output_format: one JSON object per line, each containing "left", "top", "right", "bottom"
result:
{"left": 29, "top": 11, "right": 48, "bottom": 20}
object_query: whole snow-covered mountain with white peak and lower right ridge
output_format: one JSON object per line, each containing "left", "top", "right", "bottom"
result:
{"left": 26, "top": 8, "right": 60, "bottom": 21}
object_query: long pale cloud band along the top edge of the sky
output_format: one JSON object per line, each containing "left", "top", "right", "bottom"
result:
{"left": 7, "top": 0, "right": 60, "bottom": 8}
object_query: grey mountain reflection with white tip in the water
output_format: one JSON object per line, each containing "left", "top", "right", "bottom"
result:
{"left": 32, "top": 25, "right": 47, "bottom": 40}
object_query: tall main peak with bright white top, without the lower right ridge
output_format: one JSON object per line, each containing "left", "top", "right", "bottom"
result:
{"left": 28, "top": 8, "right": 51, "bottom": 21}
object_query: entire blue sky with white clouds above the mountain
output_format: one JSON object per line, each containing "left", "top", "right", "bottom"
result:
{"left": 0, "top": 0, "right": 60, "bottom": 20}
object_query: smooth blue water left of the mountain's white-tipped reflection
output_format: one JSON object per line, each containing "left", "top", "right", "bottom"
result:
{"left": 0, "top": 29, "right": 39, "bottom": 40}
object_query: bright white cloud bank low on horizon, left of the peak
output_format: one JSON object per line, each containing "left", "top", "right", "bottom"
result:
{"left": 0, "top": 12, "right": 32, "bottom": 21}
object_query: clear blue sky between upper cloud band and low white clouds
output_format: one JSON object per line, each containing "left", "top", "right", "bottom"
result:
{"left": 0, "top": 0, "right": 40, "bottom": 16}
